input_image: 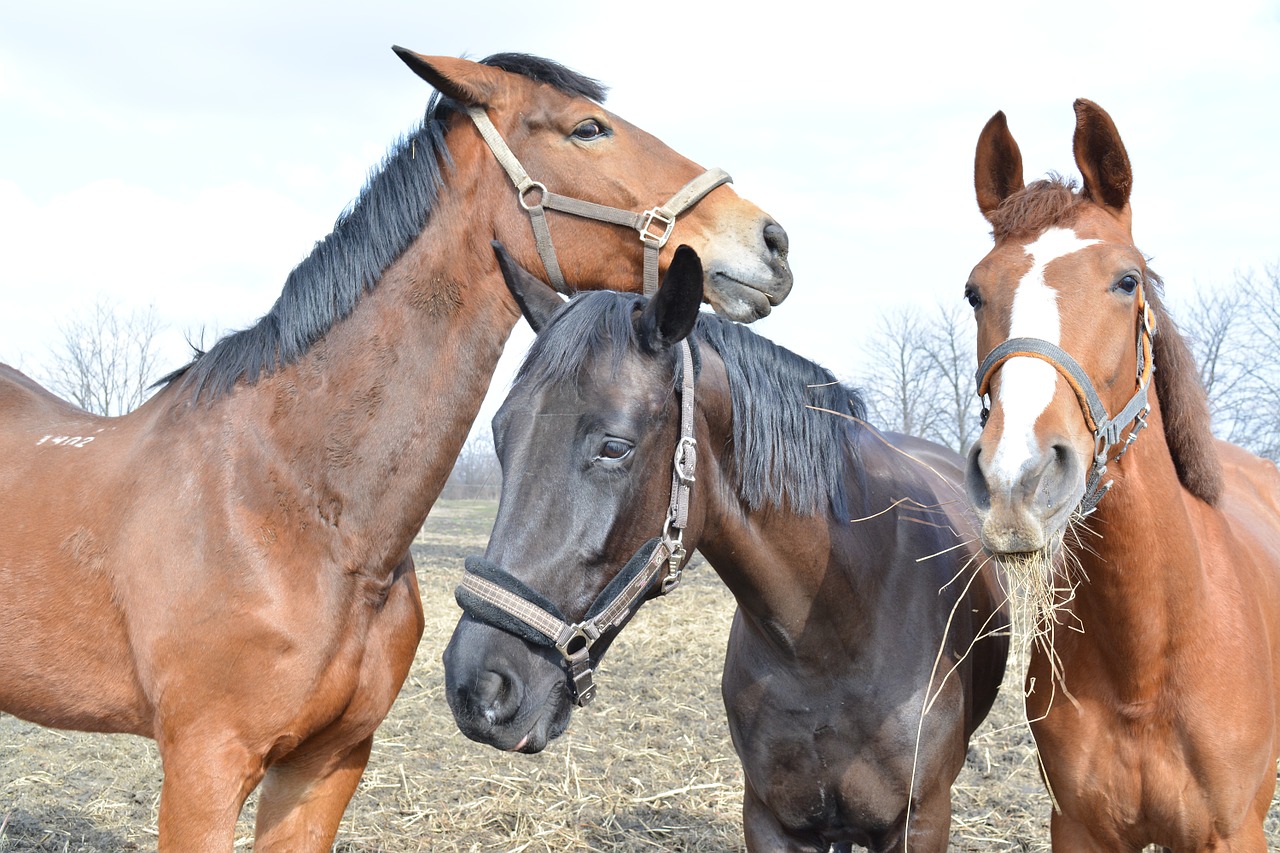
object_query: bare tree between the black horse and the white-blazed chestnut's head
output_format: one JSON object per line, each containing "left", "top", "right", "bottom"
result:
{"left": 859, "top": 302, "right": 979, "bottom": 453}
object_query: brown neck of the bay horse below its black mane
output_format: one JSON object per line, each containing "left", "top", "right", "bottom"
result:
{"left": 190, "top": 206, "right": 518, "bottom": 569}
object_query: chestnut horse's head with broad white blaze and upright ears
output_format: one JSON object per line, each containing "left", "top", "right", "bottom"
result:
{"left": 965, "top": 100, "right": 1203, "bottom": 555}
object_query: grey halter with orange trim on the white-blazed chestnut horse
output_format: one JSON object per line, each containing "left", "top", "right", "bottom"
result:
{"left": 977, "top": 283, "right": 1156, "bottom": 515}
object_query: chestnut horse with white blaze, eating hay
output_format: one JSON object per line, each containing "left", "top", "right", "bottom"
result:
{"left": 966, "top": 100, "right": 1280, "bottom": 853}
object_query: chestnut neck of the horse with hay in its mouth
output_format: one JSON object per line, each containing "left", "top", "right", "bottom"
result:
{"left": 1060, "top": 401, "right": 1206, "bottom": 701}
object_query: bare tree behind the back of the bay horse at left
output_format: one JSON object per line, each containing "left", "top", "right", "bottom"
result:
{"left": 46, "top": 298, "right": 160, "bottom": 415}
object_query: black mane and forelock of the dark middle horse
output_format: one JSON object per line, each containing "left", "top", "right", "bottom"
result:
{"left": 516, "top": 291, "right": 867, "bottom": 516}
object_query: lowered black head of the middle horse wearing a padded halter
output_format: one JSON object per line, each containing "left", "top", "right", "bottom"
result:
{"left": 444, "top": 240, "right": 703, "bottom": 752}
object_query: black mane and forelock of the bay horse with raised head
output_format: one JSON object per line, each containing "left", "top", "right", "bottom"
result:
{"left": 156, "top": 54, "right": 605, "bottom": 400}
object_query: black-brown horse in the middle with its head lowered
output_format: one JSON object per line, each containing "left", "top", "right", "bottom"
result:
{"left": 444, "top": 242, "right": 1007, "bottom": 850}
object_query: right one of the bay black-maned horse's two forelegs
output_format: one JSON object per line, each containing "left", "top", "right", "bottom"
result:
{"left": 253, "top": 735, "right": 374, "bottom": 853}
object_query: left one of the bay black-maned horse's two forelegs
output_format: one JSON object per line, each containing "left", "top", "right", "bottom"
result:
{"left": 157, "top": 743, "right": 262, "bottom": 853}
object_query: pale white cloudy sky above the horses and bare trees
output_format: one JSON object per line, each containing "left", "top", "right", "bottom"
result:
{"left": 0, "top": 0, "right": 1280, "bottom": 424}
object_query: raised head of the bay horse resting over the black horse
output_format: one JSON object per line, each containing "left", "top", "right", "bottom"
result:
{"left": 396, "top": 47, "right": 792, "bottom": 321}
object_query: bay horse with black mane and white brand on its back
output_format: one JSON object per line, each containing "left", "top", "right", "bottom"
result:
{"left": 0, "top": 50, "right": 791, "bottom": 852}
